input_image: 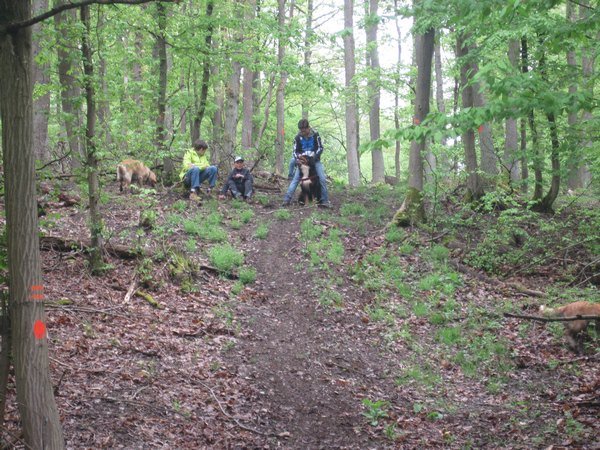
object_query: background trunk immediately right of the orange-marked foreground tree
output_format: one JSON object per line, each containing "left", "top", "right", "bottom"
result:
{"left": 31, "top": 0, "right": 50, "bottom": 163}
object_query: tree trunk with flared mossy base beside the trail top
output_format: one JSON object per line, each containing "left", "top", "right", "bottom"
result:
{"left": 392, "top": 23, "right": 435, "bottom": 226}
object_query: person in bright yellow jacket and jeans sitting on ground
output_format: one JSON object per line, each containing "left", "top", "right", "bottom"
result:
{"left": 180, "top": 139, "right": 218, "bottom": 200}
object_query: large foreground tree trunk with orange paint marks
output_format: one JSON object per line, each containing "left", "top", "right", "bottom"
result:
{"left": 0, "top": 0, "right": 64, "bottom": 449}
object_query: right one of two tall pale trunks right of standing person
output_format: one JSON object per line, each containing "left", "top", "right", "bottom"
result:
{"left": 365, "top": 0, "right": 385, "bottom": 183}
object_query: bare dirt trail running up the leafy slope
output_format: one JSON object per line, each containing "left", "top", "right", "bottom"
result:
{"left": 230, "top": 208, "right": 396, "bottom": 449}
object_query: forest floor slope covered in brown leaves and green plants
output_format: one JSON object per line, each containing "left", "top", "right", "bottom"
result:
{"left": 2, "top": 178, "right": 600, "bottom": 449}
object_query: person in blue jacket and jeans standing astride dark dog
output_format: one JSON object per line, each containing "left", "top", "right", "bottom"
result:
{"left": 283, "top": 119, "right": 331, "bottom": 208}
